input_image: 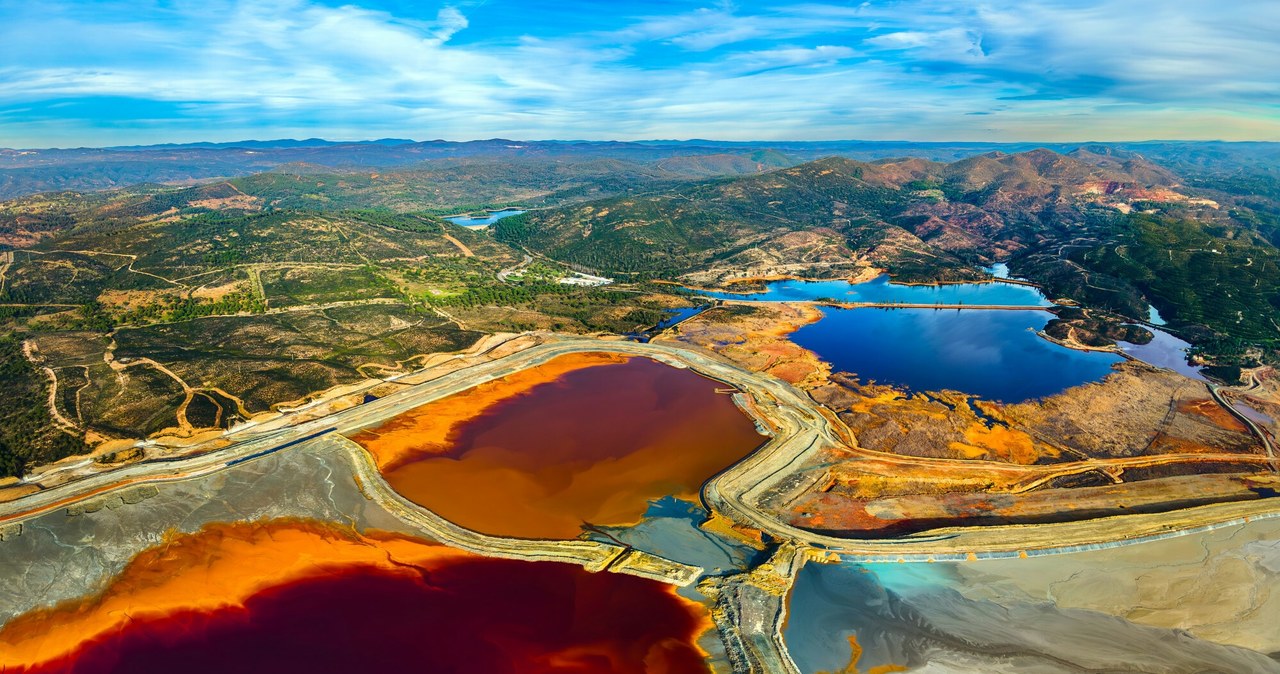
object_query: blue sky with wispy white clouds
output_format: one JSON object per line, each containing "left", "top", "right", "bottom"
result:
{"left": 0, "top": 0, "right": 1280, "bottom": 147}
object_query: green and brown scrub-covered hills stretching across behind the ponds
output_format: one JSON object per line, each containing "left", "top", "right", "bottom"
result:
{"left": 0, "top": 147, "right": 1280, "bottom": 474}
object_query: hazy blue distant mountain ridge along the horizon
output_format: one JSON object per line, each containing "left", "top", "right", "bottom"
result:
{"left": 0, "top": 138, "right": 1280, "bottom": 198}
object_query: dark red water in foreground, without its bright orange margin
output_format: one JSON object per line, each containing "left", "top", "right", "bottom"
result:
{"left": 27, "top": 559, "right": 708, "bottom": 674}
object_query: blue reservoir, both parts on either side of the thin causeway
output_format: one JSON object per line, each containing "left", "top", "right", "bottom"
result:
{"left": 705, "top": 278, "right": 1140, "bottom": 403}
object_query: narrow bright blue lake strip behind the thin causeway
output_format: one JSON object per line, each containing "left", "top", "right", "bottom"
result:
{"left": 703, "top": 276, "right": 1050, "bottom": 307}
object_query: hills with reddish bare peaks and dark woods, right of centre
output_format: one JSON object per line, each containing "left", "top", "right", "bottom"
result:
{"left": 497, "top": 146, "right": 1280, "bottom": 341}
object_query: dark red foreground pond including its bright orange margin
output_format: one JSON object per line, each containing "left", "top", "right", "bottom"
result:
{"left": 0, "top": 521, "right": 710, "bottom": 674}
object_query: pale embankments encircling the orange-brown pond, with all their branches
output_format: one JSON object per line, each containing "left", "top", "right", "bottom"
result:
{"left": 0, "top": 336, "right": 1280, "bottom": 671}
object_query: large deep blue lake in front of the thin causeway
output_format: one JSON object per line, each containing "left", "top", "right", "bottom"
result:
{"left": 791, "top": 308, "right": 1124, "bottom": 403}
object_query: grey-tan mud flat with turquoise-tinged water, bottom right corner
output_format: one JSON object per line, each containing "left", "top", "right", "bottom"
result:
{"left": 785, "top": 521, "right": 1280, "bottom": 673}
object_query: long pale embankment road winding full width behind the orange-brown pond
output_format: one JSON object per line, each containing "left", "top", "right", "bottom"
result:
{"left": 0, "top": 339, "right": 1280, "bottom": 560}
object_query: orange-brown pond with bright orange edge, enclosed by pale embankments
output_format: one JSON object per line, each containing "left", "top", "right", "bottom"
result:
{"left": 353, "top": 354, "right": 763, "bottom": 538}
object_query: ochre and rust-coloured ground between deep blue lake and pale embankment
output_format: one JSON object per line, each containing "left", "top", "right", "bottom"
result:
{"left": 663, "top": 303, "right": 1270, "bottom": 535}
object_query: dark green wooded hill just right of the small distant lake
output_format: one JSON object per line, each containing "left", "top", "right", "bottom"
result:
{"left": 495, "top": 157, "right": 921, "bottom": 276}
